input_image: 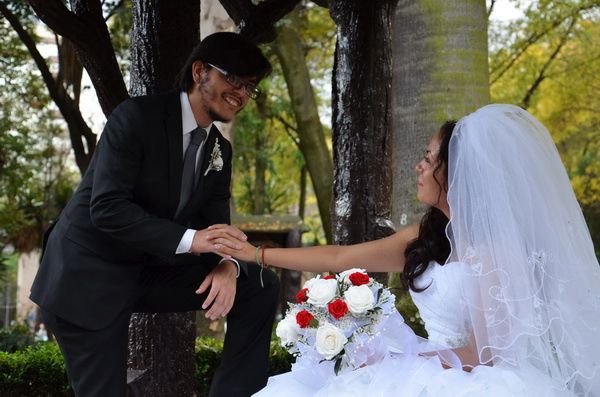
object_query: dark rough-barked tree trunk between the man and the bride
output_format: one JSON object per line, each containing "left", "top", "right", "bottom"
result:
{"left": 330, "top": 0, "right": 396, "bottom": 276}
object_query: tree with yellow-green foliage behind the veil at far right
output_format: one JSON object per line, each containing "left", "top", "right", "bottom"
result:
{"left": 490, "top": 0, "right": 600, "bottom": 256}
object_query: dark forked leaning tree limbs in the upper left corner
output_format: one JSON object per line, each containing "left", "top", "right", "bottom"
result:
{"left": 0, "top": 0, "right": 127, "bottom": 174}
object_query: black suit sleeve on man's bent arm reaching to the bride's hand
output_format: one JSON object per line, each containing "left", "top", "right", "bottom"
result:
{"left": 90, "top": 100, "right": 186, "bottom": 260}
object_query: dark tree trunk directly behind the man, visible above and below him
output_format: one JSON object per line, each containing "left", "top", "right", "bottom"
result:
{"left": 128, "top": 0, "right": 200, "bottom": 397}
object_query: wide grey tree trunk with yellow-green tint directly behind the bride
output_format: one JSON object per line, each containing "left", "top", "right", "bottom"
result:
{"left": 393, "top": 0, "right": 490, "bottom": 227}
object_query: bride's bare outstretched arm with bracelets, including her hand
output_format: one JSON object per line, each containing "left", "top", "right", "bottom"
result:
{"left": 209, "top": 224, "right": 419, "bottom": 272}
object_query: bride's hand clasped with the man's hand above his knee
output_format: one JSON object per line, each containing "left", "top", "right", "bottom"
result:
{"left": 206, "top": 224, "right": 256, "bottom": 262}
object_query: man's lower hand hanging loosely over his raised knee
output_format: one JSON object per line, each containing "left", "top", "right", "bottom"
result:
{"left": 196, "top": 261, "right": 237, "bottom": 320}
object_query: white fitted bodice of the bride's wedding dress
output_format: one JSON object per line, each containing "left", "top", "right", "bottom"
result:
{"left": 410, "top": 262, "right": 472, "bottom": 348}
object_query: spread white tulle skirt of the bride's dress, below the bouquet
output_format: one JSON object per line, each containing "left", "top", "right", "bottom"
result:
{"left": 254, "top": 334, "right": 573, "bottom": 397}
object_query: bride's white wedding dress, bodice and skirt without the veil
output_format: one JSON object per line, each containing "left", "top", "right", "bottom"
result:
{"left": 255, "top": 262, "right": 572, "bottom": 397}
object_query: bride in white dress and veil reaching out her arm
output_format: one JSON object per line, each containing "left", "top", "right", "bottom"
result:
{"left": 213, "top": 105, "right": 600, "bottom": 397}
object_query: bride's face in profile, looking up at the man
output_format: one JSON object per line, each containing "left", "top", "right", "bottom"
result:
{"left": 415, "top": 133, "right": 448, "bottom": 212}
